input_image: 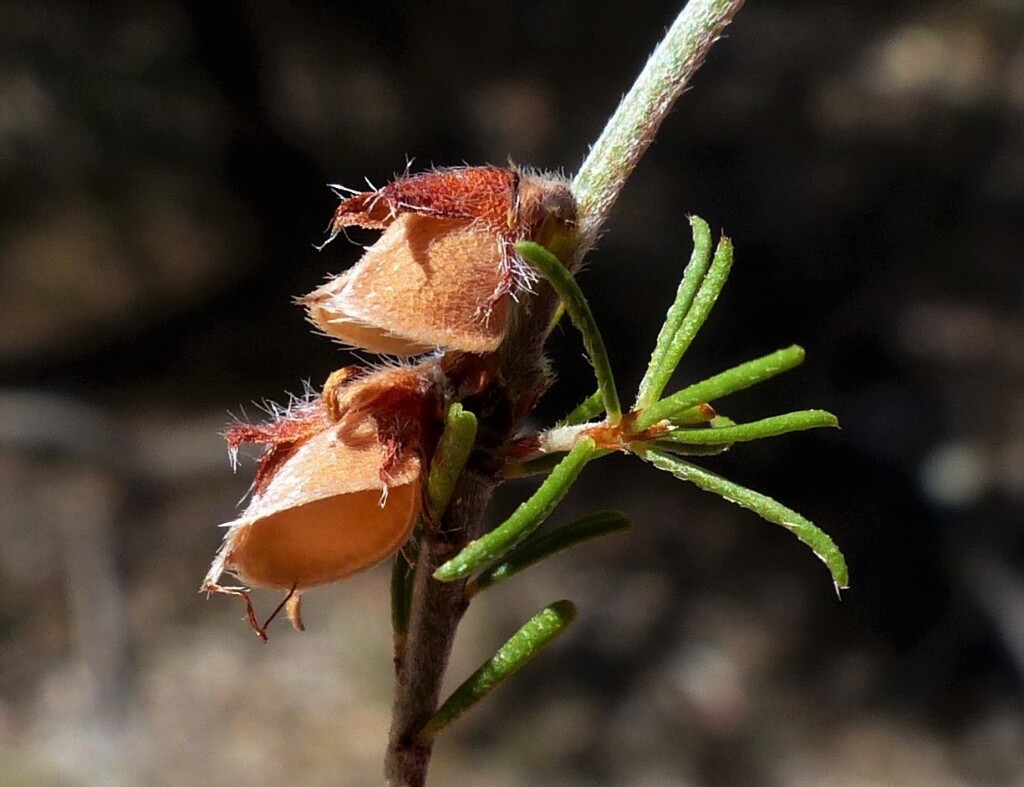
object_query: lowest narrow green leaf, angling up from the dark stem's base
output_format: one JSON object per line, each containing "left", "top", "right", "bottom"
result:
{"left": 417, "top": 601, "right": 577, "bottom": 744}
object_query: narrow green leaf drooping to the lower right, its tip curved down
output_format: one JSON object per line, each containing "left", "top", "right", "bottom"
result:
{"left": 639, "top": 449, "right": 849, "bottom": 591}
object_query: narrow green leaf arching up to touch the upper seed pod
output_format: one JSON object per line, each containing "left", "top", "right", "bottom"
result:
{"left": 515, "top": 241, "right": 623, "bottom": 425}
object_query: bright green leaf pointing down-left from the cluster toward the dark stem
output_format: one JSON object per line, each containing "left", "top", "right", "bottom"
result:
{"left": 434, "top": 437, "right": 596, "bottom": 582}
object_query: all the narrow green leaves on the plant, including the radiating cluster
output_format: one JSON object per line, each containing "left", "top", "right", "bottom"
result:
{"left": 392, "top": 216, "right": 848, "bottom": 740}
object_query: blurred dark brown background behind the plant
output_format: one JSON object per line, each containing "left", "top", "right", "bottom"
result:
{"left": 0, "top": 0, "right": 1024, "bottom": 787}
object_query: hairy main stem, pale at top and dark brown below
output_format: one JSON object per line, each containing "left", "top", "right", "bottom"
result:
{"left": 385, "top": 0, "right": 743, "bottom": 787}
